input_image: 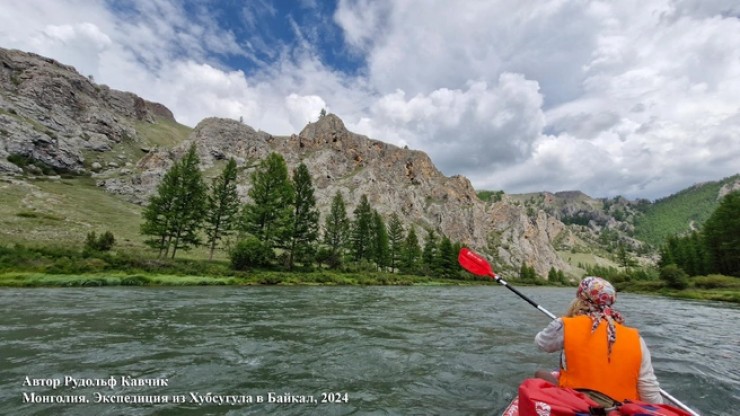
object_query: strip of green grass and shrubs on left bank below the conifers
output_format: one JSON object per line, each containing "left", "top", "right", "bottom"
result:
{"left": 0, "top": 244, "right": 487, "bottom": 287}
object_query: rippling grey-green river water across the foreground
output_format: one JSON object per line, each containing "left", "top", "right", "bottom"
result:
{"left": 0, "top": 286, "right": 740, "bottom": 415}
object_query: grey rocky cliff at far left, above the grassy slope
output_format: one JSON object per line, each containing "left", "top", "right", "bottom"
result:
{"left": 0, "top": 48, "right": 174, "bottom": 173}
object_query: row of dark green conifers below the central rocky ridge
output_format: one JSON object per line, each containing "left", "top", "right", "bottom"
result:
{"left": 141, "top": 145, "right": 472, "bottom": 278}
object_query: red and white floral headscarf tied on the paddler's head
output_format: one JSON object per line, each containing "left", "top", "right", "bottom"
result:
{"left": 576, "top": 276, "right": 624, "bottom": 354}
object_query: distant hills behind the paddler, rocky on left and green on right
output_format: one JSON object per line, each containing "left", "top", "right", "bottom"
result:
{"left": 479, "top": 175, "right": 740, "bottom": 260}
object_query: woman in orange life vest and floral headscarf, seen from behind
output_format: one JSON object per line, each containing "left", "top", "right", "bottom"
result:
{"left": 535, "top": 276, "right": 663, "bottom": 403}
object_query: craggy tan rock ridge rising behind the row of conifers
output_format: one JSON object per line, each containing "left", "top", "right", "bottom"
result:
{"left": 101, "top": 114, "right": 570, "bottom": 276}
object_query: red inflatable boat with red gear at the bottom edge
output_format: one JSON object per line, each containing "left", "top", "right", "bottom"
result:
{"left": 502, "top": 378, "right": 691, "bottom": 416}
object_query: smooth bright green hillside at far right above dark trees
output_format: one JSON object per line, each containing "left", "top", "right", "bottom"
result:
{"left": 635, "top": 175, "right": 740, "bottom": 247}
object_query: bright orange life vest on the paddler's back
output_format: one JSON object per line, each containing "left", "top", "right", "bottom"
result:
{"left": 559, "top": 316, "right": 642, "bottom": 401}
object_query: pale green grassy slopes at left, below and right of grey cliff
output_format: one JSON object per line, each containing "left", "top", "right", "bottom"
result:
{"left": 0, "top": 119, "right": 201, "bottom": 255}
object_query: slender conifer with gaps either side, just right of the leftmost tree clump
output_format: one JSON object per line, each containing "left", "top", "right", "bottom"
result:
{"left": 204, "top": 158, "right": 239, "bottom": 260}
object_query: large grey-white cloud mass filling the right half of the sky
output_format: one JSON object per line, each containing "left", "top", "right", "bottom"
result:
{"left": 330, "top": 1, "right": 740, "bottom": 197}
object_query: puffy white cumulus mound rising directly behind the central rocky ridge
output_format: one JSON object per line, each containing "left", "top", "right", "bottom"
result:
{"left": 350, "top": 73, "right": 544, "bottom": 175}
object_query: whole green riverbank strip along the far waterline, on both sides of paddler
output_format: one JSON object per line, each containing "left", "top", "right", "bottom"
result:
{"left": 0, "top": 245, "right": 740, "bottom": 303}
